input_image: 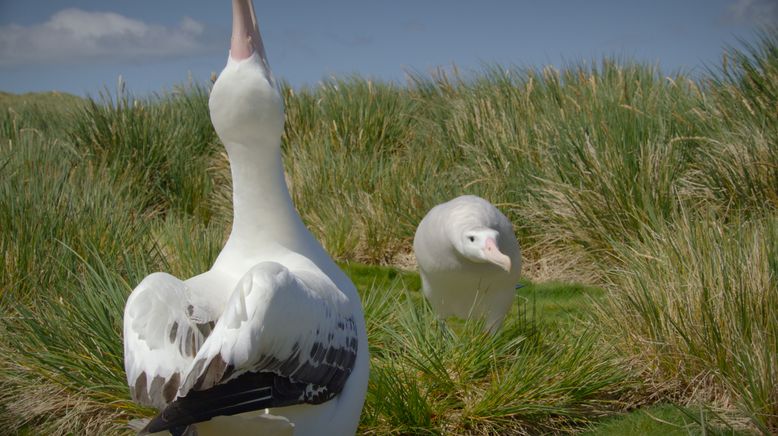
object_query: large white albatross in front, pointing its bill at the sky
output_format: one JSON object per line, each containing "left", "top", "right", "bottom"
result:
{"left": 124, "top": 0, "right": 369, "bottom": 436}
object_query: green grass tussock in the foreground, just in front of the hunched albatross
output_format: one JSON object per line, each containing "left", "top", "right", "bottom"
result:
{"left": 362, "top": 270, "right": 626, "bottom": 434}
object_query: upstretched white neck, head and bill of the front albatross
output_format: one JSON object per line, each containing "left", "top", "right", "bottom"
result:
{"left": 208, "top": 0, "right": 338, "bottom": 277}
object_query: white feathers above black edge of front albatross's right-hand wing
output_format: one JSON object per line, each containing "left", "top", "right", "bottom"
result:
{"left": 179, "top": 262, "right": 356, "bottom": 396}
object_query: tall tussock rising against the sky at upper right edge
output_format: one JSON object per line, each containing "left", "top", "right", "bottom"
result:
{"left": 699, "top": 30, "right": 778, "bottom": 215}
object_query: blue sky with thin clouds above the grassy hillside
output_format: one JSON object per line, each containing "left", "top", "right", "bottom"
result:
{"left": 0, "top": 0, "right": 778, "bottom": 95}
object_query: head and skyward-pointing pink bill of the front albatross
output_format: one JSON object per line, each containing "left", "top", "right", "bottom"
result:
{"left": 208, "top": 0, "right": 284, "bottom": 153}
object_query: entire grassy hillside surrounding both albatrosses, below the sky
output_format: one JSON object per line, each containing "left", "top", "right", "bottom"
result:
{"left": 0, "top": 32, "right": 778, "bottom": 434}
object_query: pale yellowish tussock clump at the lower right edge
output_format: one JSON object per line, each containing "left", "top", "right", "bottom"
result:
{"left": 600, "top": 214, "right": 778, "bottom": 434}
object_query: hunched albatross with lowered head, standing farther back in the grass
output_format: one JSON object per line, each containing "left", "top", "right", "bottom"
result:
{"left": 413, "top": 195, "right": 521, "bottom": 333}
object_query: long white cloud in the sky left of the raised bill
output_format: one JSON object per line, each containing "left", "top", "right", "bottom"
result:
{"left": 0, "top": 9, "right": 213, "bottom": 66}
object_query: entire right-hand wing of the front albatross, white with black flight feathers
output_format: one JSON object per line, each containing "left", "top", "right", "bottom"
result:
{"left": 147, "top": 262, "right": 358, "bottom": 432}
